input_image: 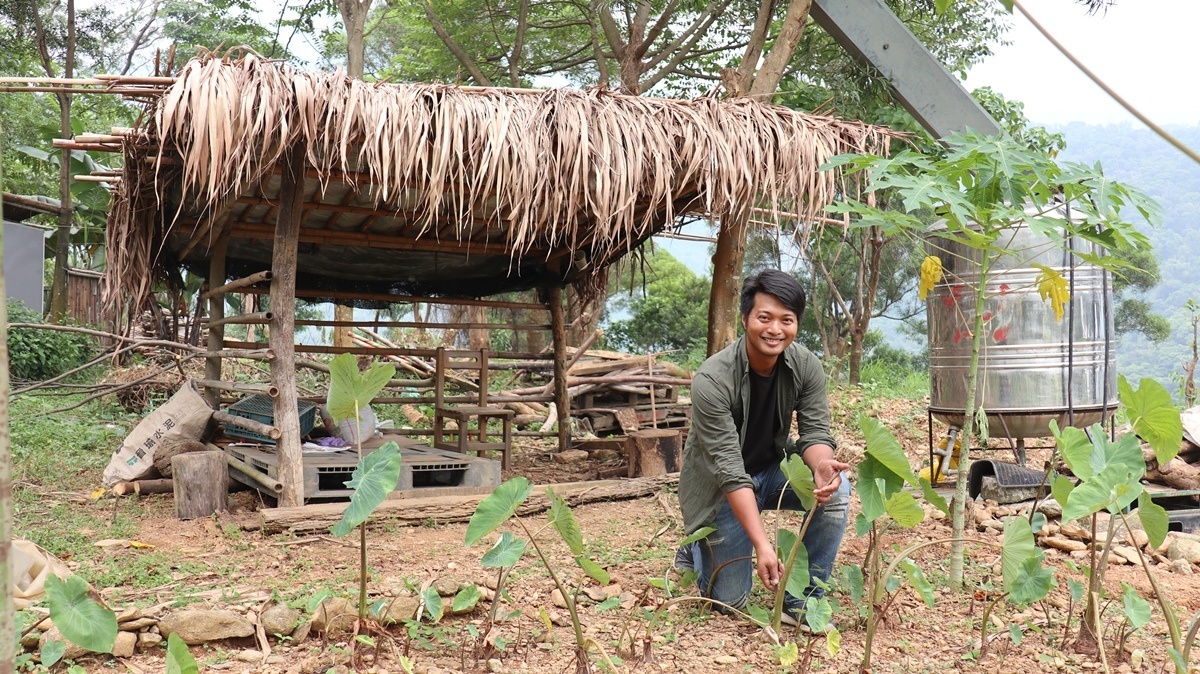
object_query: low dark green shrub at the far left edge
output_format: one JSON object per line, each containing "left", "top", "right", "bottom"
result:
{"left": 8, "top": 299, "right": 92, "bottom": 381}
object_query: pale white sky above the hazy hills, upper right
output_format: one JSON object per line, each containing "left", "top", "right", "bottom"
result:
{"left": 965, "top": 0, "right": 1200, "bottom": 126}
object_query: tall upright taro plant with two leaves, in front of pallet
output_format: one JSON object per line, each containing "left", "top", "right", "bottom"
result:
{"left": 329, "top": 354, "right": 401, "bottom": 633}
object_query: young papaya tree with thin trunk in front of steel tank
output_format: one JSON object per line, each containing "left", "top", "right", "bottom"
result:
{"left": 828, "top": 133, "right": 1157, "bottom": 588}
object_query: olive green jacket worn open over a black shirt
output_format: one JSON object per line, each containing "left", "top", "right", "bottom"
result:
{"left": 679, "top": 337, "right": 836, "bottom": 534}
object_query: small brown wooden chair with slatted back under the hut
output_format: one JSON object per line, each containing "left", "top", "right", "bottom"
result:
{"left": 433, "top": 347, "right": 516, "bottom": 470}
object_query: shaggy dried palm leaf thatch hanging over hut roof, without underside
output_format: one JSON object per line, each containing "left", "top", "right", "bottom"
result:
{"left": 109, "top": 54, "right": 895, "bottom": 314}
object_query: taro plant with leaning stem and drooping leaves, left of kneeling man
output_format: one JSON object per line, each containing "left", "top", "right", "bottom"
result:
{"left": 464, "top": 477, "right": 616, "bottom": 674}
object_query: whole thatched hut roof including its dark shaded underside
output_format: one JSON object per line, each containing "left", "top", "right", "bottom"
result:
{"left": 107, "top": 55, "right": 893, "bottom": 311}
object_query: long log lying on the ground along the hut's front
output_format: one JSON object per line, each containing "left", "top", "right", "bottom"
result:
{"left": 258, "top": 474, "right": 679, "bottom": 534}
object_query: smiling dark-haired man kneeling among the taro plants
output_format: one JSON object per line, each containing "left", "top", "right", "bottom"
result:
{"left": 677, "top": 270, "right": 850, "bottom": 622}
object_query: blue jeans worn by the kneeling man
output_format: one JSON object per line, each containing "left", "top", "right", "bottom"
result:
{"left": 696, "top": 465, "right": 850, "bottom": 610}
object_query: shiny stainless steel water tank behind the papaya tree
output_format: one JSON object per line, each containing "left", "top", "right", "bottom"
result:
{"left": 926, "top": 225, "right": 1117, "bottom": 438}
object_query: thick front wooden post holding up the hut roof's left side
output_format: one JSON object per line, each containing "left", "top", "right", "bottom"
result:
{"left": 269, "top": 148, "right": 304, "bottom": 507}
